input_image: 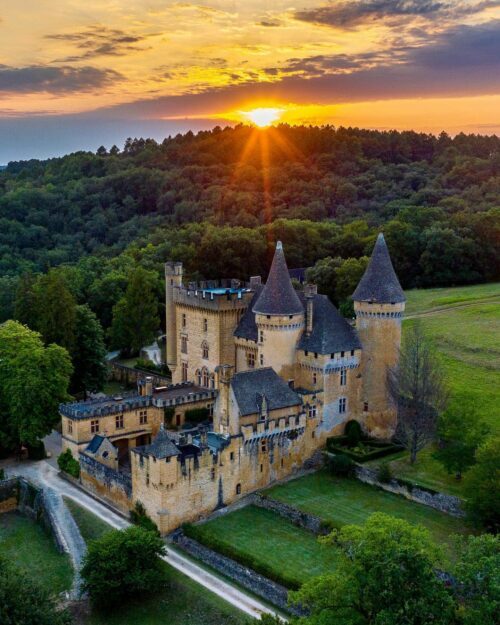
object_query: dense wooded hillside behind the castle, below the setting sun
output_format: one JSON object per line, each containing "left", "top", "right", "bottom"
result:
{"left": 0, "top": 126, "right": 500, "bottom": 330}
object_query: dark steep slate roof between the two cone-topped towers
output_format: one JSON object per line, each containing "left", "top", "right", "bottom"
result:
{"left": 297, "top": 293, "right": 361, "bottom": 354}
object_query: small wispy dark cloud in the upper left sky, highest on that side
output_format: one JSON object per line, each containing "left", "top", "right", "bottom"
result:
{"left": 45, "top": 25, "right": 146, "bottom": 62}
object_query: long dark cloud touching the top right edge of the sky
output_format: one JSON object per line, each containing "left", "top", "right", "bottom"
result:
{"left": 295, "top": 0, "right": 500, "bottom": 28}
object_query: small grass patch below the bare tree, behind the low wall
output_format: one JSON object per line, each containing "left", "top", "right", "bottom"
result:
{"left": 367, "top": 446, "right": 463, "bottom": 497}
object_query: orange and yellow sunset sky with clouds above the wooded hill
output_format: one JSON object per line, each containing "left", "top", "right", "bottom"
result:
{"left": 0, "top": 0, "right": 500, "bottom": 164}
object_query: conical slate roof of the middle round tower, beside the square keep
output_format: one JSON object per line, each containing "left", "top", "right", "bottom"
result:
{"left": 253, "top": 241, "right": 304, "bottom": 315}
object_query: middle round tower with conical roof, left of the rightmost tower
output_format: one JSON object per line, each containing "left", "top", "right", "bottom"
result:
{"left": 253, "top": 241, "right": 304, "bottom": 381}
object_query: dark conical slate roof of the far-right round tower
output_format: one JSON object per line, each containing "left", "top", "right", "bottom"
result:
{"left": 352, "top": 233, "right": 406, "bottom": 304}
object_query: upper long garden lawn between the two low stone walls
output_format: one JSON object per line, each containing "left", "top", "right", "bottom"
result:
{"left": 266, "top": 471, "right": 469, "bottom": 560}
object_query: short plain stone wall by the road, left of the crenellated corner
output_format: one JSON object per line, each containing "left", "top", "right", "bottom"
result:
{"left": 80, "top": 453, "right": 132, "bottom": 513}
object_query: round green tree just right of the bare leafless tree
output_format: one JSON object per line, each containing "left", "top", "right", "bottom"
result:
{"left": 434, "top": 402, "right": 488, "bottom": 480}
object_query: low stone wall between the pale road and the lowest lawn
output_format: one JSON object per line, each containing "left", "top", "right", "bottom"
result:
{"left": 170, "top": 530, "right": 304, "bottom": 616}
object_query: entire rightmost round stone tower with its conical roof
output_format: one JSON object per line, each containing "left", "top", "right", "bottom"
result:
{"left": 352, "top": 233, "right": 406, "bottom": 437}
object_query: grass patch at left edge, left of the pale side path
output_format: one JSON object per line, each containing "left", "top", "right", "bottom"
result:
{"left": 0, "top": 512, "right": 73, "bottom": 594}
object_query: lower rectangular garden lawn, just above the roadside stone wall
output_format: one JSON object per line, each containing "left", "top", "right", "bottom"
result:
{"left": 188, "top": 506, "right": 337, "bottom": 585}
